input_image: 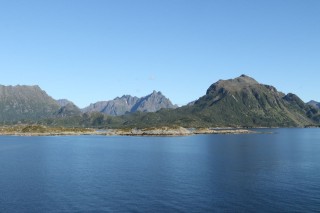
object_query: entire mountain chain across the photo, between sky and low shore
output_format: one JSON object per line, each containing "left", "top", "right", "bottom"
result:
{"left": 0, "top": 75, "right": 320, "bottom": 128}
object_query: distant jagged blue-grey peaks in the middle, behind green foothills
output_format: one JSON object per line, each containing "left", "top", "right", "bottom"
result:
{"left": 82, "top": 91, "right": 177, "bottom": 116}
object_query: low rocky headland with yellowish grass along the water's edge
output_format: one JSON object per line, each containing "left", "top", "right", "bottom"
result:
{"left": 0, "top": 125, "right": 256, "bottom": 136}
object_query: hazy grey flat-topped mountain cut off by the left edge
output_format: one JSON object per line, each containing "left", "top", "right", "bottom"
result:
{"left": 0, "top": 85, "right": 60, "bottom": 123}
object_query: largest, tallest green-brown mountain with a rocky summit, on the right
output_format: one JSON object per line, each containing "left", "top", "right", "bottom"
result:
{"left": 184, "top": 75, "right": 313, "bottom": 127}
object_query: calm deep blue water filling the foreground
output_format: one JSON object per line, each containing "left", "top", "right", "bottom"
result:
{"left": 0, "top": 129, "right": 320, "bottom": 212}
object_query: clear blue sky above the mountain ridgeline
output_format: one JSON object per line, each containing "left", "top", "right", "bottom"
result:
{"left": 0, "top": 0, "right": 320, "bottom": 107}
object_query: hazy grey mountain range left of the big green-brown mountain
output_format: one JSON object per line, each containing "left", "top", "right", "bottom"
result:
{"left": 0, "top": 85, "right": 177, "bottom": 124}
